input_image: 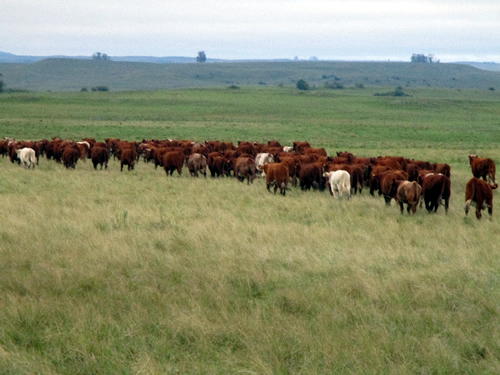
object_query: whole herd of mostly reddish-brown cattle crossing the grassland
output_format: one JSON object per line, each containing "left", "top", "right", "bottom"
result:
{"left": 0, "top": 138, "right": 498, "bottom": 219}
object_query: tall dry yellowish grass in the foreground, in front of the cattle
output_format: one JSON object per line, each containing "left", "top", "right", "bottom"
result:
{"left": 0, "top": 151, "right": 500, "bottom": 374}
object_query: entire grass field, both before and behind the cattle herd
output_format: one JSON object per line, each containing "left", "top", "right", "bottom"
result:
{"left": 0, "top": 87, "right": 500, "bottom": 374}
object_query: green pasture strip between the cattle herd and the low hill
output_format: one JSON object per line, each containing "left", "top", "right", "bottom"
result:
{"left": 0, "top": 88, "right": 500, "bottom": 157}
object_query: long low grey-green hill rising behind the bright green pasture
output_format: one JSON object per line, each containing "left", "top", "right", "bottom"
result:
{"left": 0, "top": 56, "right": 500, "bottom": 91}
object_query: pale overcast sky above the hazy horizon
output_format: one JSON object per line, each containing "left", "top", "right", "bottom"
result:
{"left": 0, "top": 0, "right": 500, "bottom": 63}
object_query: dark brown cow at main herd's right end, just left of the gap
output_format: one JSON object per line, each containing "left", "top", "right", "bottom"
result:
{"left": 419, "top": 173, "right": 451, "bottom": 213}
